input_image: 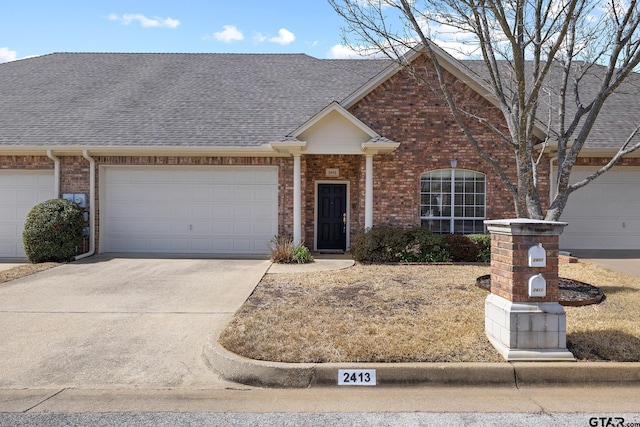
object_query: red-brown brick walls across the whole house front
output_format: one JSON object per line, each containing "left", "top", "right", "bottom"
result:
{"left": 0, "top": 56, "right": 640, "bottom": 254}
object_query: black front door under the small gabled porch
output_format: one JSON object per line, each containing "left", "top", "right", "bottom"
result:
{"left": 317, "top": 184, "right": 347, "bottom": 251}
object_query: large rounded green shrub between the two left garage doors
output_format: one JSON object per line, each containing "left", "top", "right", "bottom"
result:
{"left": 22, "top": 199, "right": 84, "bottom": 263}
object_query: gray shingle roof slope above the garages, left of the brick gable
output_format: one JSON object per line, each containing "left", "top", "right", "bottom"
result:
{"left": 0, "top": 53, "right": 388, "bottom": 148}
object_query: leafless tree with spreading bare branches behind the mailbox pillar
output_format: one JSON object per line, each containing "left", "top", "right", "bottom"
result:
{"left": 328, "top": 0, "right": 640, "bottom": 220}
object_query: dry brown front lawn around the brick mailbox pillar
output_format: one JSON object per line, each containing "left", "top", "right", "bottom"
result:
{"left": 220, "top": 263, "right": 640, "bottom": 362}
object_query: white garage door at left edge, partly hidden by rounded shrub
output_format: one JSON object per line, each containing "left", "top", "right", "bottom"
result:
{"left": 0, "top": 170, "right": 55, "bottom": 258}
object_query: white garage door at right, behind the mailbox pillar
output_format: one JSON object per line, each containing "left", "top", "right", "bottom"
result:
{"left": 560, "top": 167, "right": 640, "bottom": 250}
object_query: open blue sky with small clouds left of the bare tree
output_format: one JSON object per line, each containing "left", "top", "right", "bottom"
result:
{"left": 0, "top": 0, "right": 356, "bottom": 62}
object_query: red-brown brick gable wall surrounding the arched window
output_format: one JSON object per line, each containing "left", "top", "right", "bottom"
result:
{"left": 351, "top": 56, "right": 549, "bottom": 226}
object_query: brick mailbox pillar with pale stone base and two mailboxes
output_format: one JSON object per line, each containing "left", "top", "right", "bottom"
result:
{"left": 485, "top": 219, "right": 575, "bottom": 361}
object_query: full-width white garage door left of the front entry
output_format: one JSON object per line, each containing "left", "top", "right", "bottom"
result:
{"left": 100, "top": 166, "right": 278, "bottom": 254}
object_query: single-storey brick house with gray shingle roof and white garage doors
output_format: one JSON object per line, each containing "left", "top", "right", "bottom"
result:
{"left": 0, "top": 46, "right": 640, "bottom": 257}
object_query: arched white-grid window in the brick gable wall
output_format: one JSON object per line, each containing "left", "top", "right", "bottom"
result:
{"left": 420, "top": 169, "right": 486, "bottom": 234}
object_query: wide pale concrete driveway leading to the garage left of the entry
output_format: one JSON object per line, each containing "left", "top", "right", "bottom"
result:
{"left": 0, "top": 256, "right": 270, "bottom": 389}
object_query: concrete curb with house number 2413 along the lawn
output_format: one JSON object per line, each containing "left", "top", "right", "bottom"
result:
{"left": 204, "top": 336, "right": 640, "bottom": 388}
